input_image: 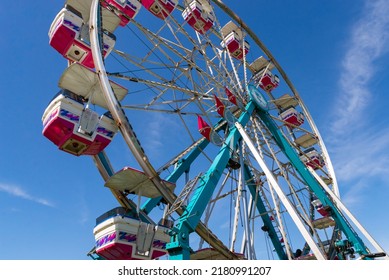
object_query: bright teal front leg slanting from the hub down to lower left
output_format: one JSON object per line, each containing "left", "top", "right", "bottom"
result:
{"left": 166, "top": 102, "right": 255, "bottom": 260}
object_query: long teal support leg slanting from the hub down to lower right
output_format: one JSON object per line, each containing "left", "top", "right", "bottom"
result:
{"left": 249, "top": 86, "right": 368, "bottom": 254}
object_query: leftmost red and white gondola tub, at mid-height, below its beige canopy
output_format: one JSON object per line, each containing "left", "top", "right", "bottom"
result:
{"left": 42, "top": 90, "right": 118, "bottom": 156}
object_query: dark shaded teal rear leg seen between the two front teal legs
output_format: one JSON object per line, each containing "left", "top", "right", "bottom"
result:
{"left": 244, "top": 165, "right": 288, "bottom": 260}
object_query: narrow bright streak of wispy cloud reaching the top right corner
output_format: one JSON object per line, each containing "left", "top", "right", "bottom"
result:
{"left": 331, "top": 0, "right": 389, "bottom": 134}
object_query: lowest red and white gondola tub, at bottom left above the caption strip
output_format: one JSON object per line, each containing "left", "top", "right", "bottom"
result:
{"left": 93, "top": 207, "right": 170, "bottom": 260}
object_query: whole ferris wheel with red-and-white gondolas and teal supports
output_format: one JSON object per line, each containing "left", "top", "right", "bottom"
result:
{"left": 42, "top": 0, "right": 388, "bottom": 259}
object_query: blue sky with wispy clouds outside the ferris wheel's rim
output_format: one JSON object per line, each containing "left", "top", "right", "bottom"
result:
{"left": 0, "top": 0, "right": 389, "bottom": 259}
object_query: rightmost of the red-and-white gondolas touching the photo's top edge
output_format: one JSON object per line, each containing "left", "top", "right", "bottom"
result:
{"left": 182, "top": 0, "right": 215, "bottom": 34}
